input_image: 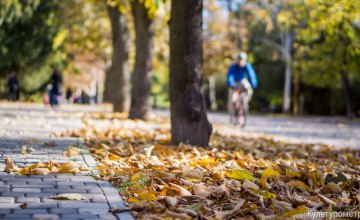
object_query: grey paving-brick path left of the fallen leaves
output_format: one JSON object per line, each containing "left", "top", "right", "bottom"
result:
{"left": 0, "top": 103, "right": 132, "bottom": 220}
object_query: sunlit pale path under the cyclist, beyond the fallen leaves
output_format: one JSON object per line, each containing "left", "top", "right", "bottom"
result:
{"left": 154, "top": 110, "right": 360, "bottom": 149}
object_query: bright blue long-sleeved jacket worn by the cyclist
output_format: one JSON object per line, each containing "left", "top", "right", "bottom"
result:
{"left": 227, "top": 63, "right": 258, "bottom": 89}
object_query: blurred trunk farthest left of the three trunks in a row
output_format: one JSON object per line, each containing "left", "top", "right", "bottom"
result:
{"left": 104, "top": 3, "right": 130, "bottom": 111}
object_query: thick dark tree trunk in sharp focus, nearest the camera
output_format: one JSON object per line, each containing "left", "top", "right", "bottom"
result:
{"left": 170, "top": 0, "right": 212, "bottom": 146}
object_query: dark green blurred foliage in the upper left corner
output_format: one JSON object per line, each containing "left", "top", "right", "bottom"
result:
{"left": 0, "top": 0, "right": 60, "bottom": 92}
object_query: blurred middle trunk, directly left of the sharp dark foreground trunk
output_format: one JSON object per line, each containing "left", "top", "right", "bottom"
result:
{"left": 130, "top": 0, "right": 154, "bottom": 120}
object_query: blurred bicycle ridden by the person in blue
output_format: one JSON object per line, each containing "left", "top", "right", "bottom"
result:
{"left": 230, "top": 86, "right": 249, "bottom": 128}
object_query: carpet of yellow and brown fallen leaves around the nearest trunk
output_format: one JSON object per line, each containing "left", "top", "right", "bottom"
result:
{"left": 59, "top": 114, "right": 360, "bottom": 219}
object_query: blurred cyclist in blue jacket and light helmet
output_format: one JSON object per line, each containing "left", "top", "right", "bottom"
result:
{"left": 227, "top": 52, "right": 258, "bottom": 126}
